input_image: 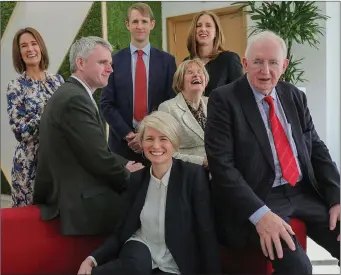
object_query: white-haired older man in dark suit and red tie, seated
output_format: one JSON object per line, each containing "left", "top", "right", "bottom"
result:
{"left": 205, "top": 31, "right": 340, "bottom": 274}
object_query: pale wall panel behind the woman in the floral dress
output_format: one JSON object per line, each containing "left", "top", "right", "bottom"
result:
{"left": 1, "top": 2, "right": 92, "bottom": 181}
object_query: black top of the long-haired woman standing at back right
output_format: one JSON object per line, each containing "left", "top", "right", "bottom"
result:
{"left": 184, "top": 51, "right": 243, "bottom": 96}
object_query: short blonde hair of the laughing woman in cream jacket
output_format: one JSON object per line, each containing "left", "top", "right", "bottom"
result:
{"left": 172, "top": 58, "right": 210, "bottom": 94}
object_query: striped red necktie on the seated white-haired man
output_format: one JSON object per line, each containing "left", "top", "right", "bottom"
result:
{"left": 264, "top": 96, "right": 299, "bottom": 186}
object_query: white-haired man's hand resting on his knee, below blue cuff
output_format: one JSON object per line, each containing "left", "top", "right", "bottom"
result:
{"left": 256, "top": 211, "right": 296, "bottom": 260}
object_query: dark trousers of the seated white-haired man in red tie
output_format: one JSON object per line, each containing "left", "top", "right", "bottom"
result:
{"left": 250, "top": 182, "right": 340, "bottom": 275}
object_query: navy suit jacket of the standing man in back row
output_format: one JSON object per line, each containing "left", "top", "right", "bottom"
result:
{"left": 101, "top": 47, "right": 176, "bottom": 163}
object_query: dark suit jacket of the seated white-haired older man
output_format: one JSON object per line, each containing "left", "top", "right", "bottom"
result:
{"left": 205, "top": 75, "right": 340, "bottom": 249}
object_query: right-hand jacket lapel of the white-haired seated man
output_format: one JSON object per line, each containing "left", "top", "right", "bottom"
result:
{"left": 276, "top": 85, "right": 304, "bottom": 163}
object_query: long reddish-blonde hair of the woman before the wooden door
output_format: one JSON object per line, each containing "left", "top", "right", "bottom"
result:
{"left": 187, "top": 11, "right": 225, "bottom": 59}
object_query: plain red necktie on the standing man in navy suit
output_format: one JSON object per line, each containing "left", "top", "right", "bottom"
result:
{"left": 134, "top": 50, "right": 147, "bottom": 121}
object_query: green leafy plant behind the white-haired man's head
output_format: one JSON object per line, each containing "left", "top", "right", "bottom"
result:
{"left": 232, "top": 1, "right": 329, "bottom": 84}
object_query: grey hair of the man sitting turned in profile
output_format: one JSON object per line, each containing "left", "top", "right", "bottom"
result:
{"left": 69, "top": 36, "right": 112, "bottom": 73}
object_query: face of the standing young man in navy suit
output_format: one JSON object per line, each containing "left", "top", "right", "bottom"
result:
{"left": 126, "top": 9, "right": 155, "bottom": 44}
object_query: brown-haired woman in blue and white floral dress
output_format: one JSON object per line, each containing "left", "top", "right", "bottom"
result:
{"left": 7, "top": 28, "right": 64, "bottom": 207}
